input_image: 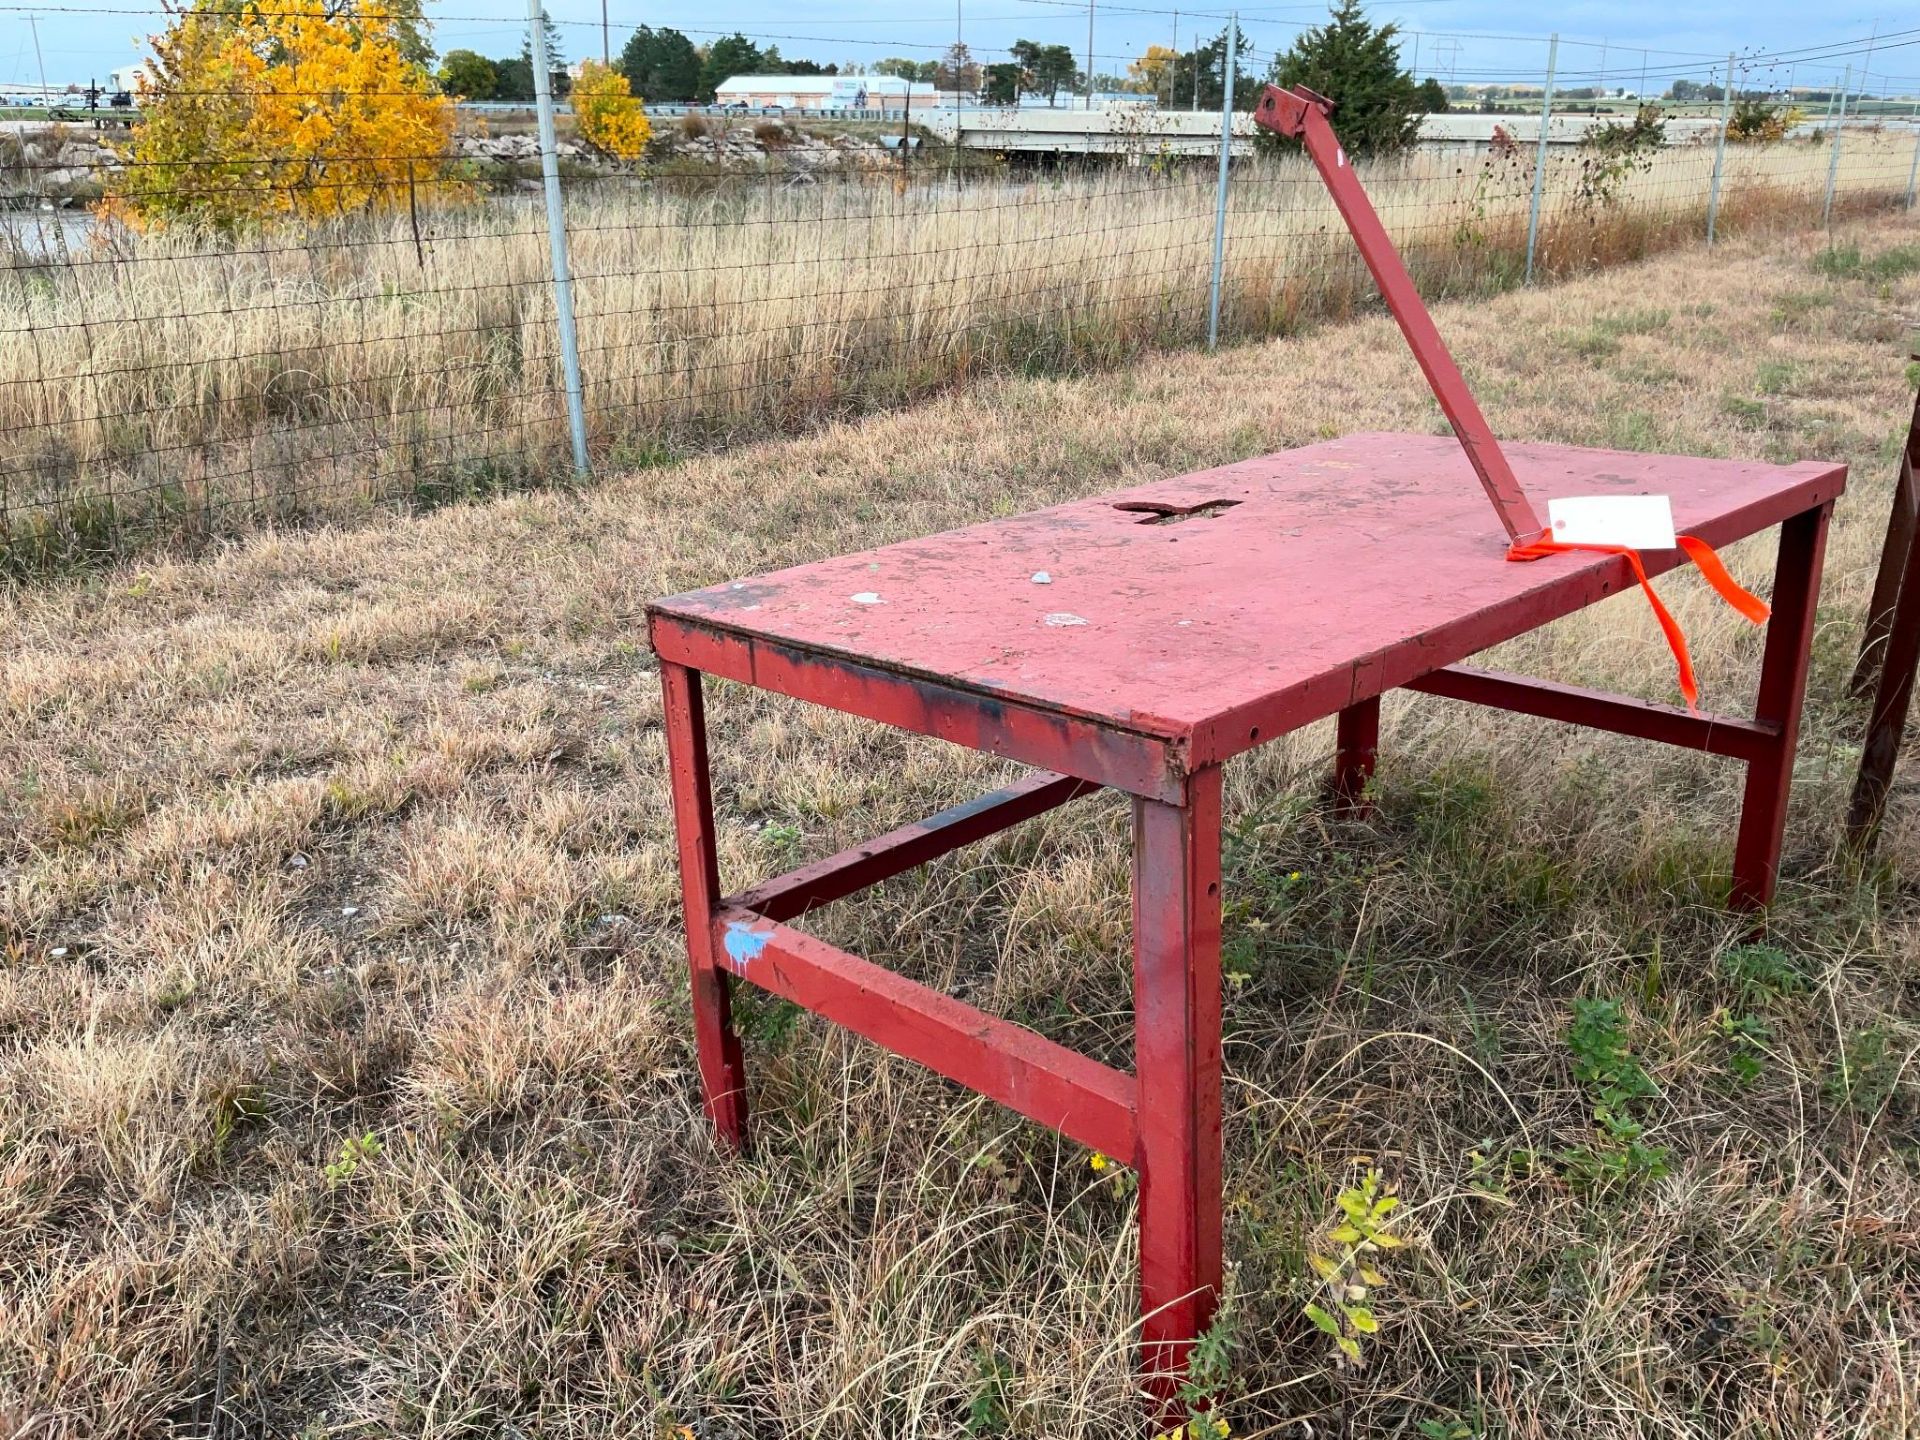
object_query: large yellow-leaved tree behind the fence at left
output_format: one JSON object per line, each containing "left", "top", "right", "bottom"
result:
{"left": 102, "top": 0, "right": 453, "bottom": 230}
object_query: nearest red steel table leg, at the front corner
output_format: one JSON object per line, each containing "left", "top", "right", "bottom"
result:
{"left": 1133, "top": 766, "right": 1221, "bottom": 1423}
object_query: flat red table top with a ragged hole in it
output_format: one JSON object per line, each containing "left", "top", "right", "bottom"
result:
{"left": 649, "top": 434, "right": 1845, "bottom": 749}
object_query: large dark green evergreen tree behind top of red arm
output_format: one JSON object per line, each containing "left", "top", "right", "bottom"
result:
{"left": 1261, "top": 0, "right": 1423, "bottom": 156}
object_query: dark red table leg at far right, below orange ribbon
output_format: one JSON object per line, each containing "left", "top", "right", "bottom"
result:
{"left": 1730, "top": 503, "right": 1834, "bottom": 910}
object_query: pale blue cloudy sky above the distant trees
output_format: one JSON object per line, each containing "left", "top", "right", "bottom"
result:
{"left": 0, "top": 0, "right": 1920, "bottom": 94}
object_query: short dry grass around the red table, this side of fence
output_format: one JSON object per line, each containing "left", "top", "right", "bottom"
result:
{"left": 0, "top": 208, "right": 1920, "bottom": 1440}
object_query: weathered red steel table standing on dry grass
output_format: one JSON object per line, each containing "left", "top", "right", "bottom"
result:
{"left": 649, "top": 434, "right": 1845, "bottom": 1396}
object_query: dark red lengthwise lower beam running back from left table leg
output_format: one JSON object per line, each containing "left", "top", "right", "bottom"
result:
{"left": 722, "top": 770, "right": 1100, "bottom": 920}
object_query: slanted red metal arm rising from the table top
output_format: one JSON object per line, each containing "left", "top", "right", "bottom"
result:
{"left": 1254, "top": 84, "right": 1546, "bottom": 540}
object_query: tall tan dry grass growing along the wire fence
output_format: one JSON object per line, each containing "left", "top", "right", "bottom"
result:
{"left": 0, "top": 136, "right": 1910, "bottom": 574}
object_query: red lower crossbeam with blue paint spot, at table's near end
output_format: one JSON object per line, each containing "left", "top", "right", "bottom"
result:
{"left": 712, "top": 908, "right": 1139, "bottom": 1164}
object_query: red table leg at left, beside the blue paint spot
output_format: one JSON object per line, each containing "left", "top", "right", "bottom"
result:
{"left": 660, "top": 660, "right": 747, "bottom": 1148}
